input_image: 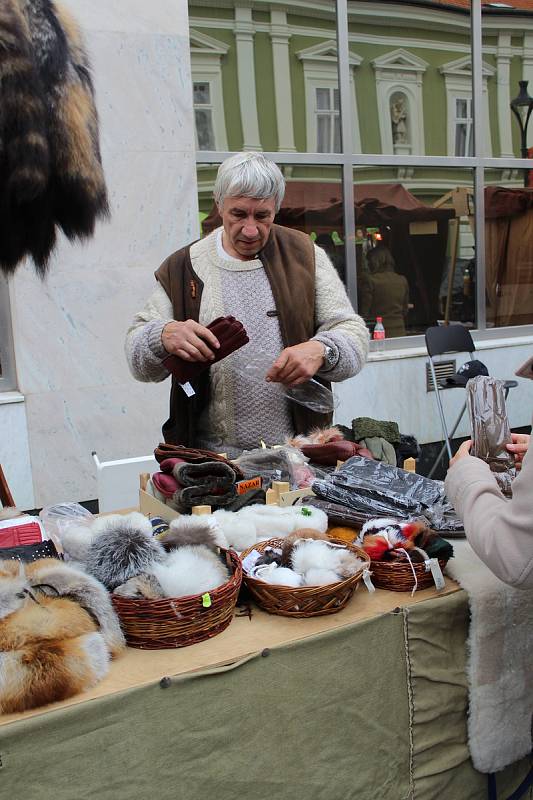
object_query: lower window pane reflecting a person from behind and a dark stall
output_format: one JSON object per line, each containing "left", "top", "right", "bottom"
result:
{"left": 354, "top": 168, "right": 476, "bottom": 338}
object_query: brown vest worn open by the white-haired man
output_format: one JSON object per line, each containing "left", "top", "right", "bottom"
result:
{"left": 155, "top": 225, "right": 332, "bottom": 447}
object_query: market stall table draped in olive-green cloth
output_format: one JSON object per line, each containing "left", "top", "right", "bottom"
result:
{"left": 0, "top": 580, "right": 527, "bottom": 800}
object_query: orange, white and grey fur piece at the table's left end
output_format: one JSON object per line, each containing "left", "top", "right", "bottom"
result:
{"left": 0, "top": 561, "right": 109, "bottom": 714}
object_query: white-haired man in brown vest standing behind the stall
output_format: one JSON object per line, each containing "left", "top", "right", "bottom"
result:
{"left": 126, "top": 152, "right": 369, "bottom": 457}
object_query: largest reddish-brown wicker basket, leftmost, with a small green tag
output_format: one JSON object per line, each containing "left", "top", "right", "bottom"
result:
{"left": 111, "top": 550, "right": 242, "bottom": 650}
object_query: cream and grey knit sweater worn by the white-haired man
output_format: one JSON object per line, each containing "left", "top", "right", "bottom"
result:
{"left": 125, "top": 228, "right": 369, "bottom": 456}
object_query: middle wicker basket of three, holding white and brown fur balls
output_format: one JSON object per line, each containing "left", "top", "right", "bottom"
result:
{"left": 241, "top": 539, "right": 370, "bottom": 617}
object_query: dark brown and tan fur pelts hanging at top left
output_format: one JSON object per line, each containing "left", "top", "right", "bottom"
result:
{"left": 0, "top": 0, "right": 109, "bottom": 276}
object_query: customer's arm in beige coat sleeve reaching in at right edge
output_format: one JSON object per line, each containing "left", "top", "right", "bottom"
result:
{"left": 444, "top": 433, "right": 533, "bottom": 589}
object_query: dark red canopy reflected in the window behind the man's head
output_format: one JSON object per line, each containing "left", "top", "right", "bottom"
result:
{"left": 202, "top": 181, "right": 454, "bottom": 235}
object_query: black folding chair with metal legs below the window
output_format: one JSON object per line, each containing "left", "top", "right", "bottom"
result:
{"left": 426, "top": 325, "right": 518, "bottom": 478}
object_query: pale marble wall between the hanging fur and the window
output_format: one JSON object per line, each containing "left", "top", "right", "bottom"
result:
{"left": 10, "top": 0, "right": 198, "bottom": 506}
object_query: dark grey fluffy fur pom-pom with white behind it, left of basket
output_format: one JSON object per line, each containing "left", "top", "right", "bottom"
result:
{"left": 85, "top": 512, "right": 165, "bottom": 591}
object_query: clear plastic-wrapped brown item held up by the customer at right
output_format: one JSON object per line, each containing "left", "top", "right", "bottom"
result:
{"left": 466, "top": 375, "right": 516, "bottom": 497}
